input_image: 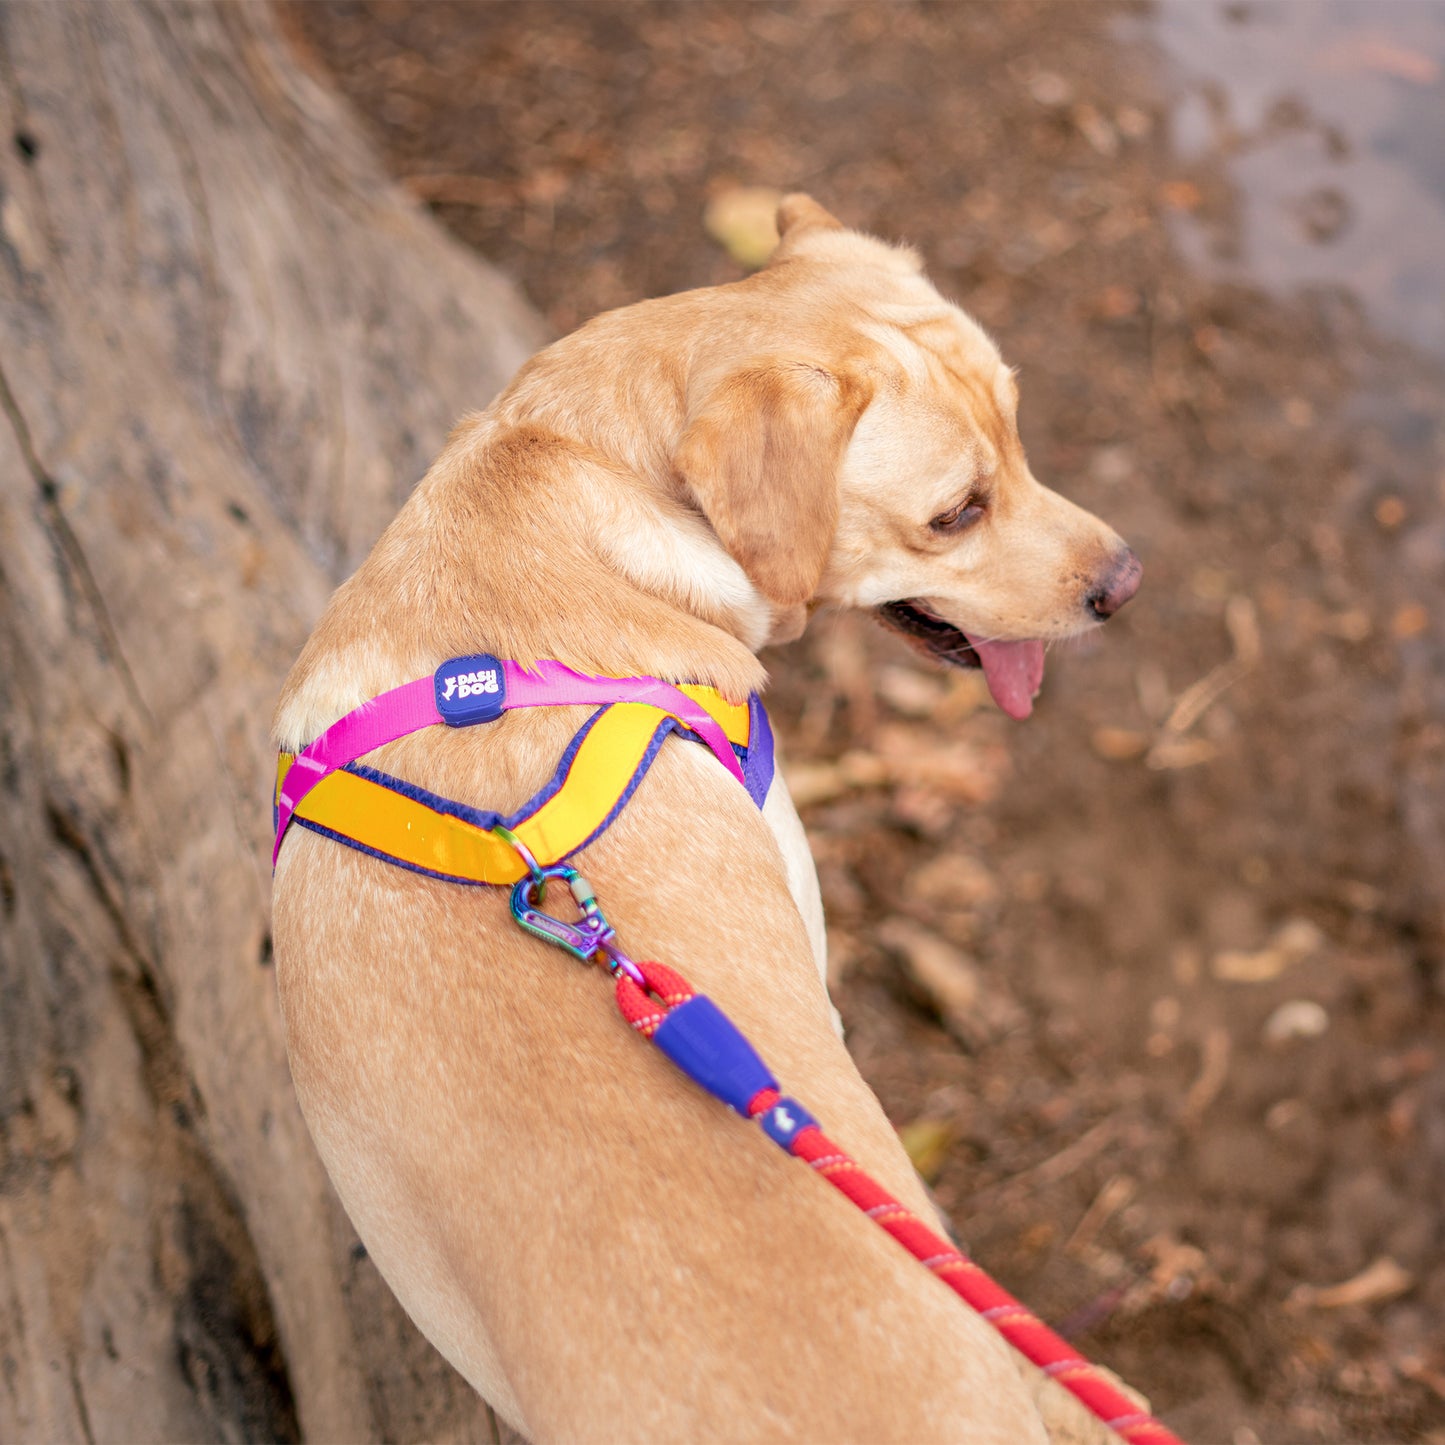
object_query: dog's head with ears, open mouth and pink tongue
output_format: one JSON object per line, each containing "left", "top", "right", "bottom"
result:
{"left": 673, "top": 197, "right": 1140, "bottom": 717}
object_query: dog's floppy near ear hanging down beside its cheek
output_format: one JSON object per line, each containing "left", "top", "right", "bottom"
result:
{"left": 673, "top": 357, "right": 868, "bottom": 607}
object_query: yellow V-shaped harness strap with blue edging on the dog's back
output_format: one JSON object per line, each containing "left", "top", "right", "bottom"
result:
{"left": 276, "top": 683, "right": 751, "bottom": 883}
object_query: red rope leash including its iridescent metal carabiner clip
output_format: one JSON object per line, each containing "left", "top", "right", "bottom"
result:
{"left": 509, "top": 861, "right": 1183, "bottom": 1445}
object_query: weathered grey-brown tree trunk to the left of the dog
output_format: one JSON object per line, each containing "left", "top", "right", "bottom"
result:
{"left": 0, "top": 3, "right": 543, "bottom": 1441}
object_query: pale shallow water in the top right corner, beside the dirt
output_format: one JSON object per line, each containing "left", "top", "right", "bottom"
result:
{"left": 1147, "top": 0, "right": 1445, "bottom": 355}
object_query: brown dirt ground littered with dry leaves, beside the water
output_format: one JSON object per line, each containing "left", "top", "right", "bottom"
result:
{"left": 288, "top": 0, "right": 1445, "bottom": 1445}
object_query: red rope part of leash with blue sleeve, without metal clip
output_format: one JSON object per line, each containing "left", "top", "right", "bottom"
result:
{"left": 617, "top": 961, "right": 1182, "bottom": 1445}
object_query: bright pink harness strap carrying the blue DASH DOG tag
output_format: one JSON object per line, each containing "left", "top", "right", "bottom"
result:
{"left": 272, "top": 655, "right": 762, "bottom": 867}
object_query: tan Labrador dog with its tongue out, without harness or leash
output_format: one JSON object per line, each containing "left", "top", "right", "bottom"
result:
{"left": 275, "top": 197, "right": 1139, "bottom": 1445}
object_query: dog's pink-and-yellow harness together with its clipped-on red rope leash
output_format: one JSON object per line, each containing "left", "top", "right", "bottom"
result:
{"left": 272, "top": 653, "right": 1182, "bottom": 1445}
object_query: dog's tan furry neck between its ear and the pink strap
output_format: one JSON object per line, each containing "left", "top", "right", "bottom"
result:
{"left": 275, "top": 412, "right": 776, "bottom": 749}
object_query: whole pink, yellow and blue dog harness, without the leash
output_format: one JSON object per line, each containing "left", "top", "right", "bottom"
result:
{"left": 272, "top": 653, "right": 773, "bottom": 884}
